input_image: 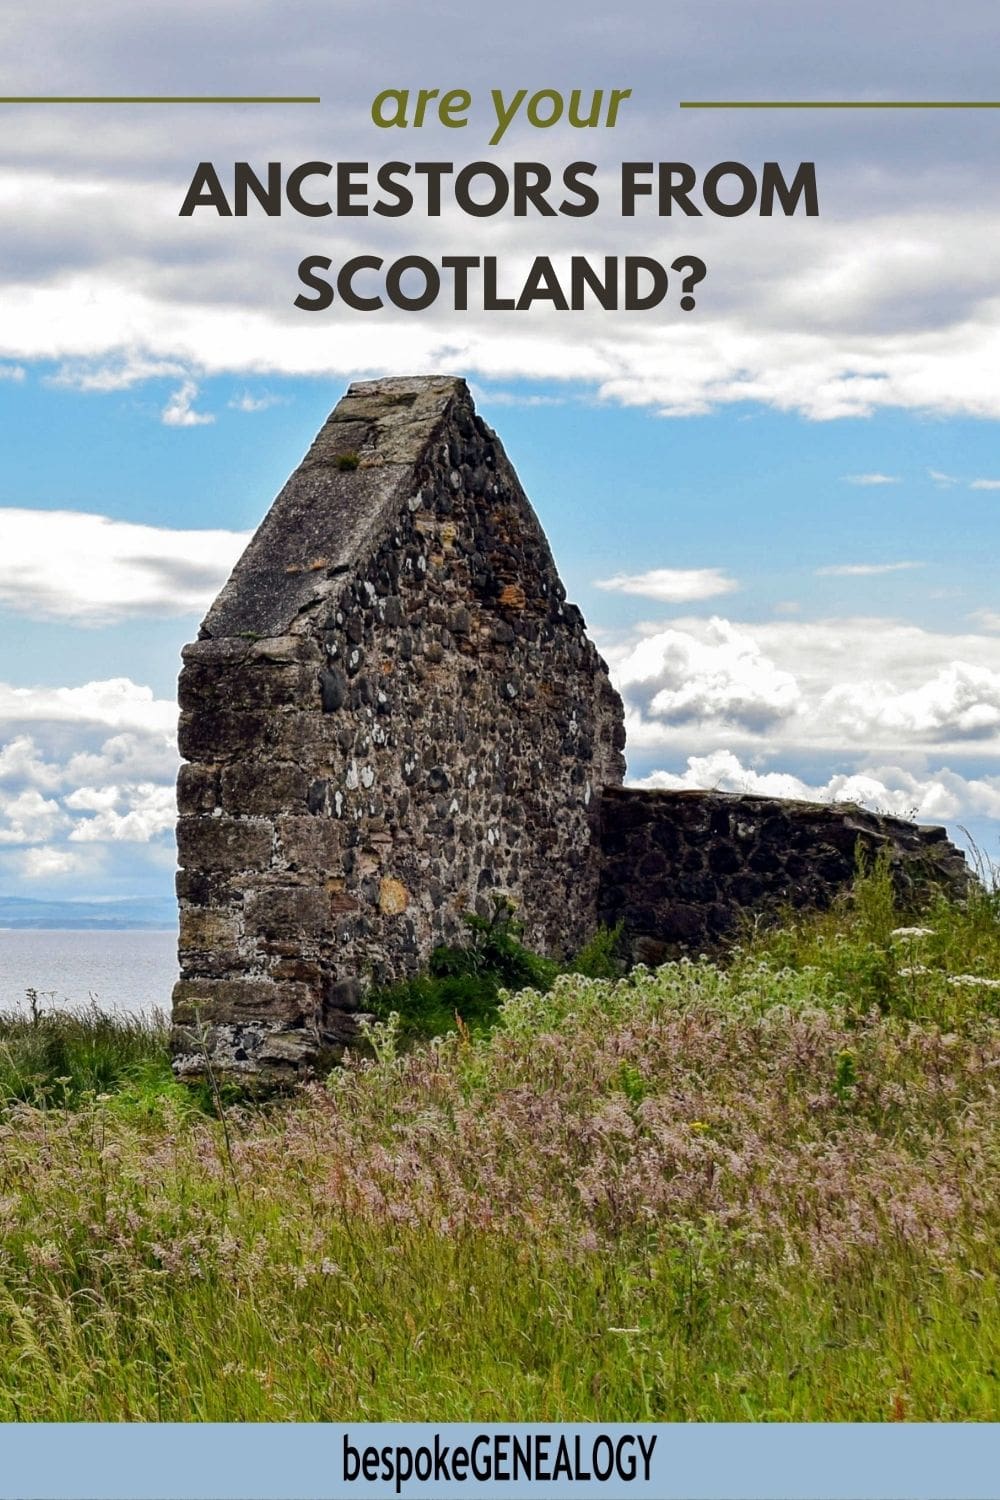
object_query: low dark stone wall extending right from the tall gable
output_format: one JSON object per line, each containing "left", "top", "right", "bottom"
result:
{"left": 598, "top": 788, "right": 970, "bottom": 965}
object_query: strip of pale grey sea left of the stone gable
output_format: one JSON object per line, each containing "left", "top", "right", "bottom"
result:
{"left": 0, "top": 929, "right": 177, "bottom": 1016}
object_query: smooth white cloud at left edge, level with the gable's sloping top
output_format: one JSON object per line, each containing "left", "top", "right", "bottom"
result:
{"left": 0, "top": 509, "right": 247, "bottom": 626}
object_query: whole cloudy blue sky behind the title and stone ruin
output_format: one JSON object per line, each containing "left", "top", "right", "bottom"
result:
{"left": 0, "top": 0, "right": 1000, "bottom": 900}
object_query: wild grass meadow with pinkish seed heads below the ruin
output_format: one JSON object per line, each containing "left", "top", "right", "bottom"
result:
{"left": 0, "top": 867, "right": 1000, "bottom": 1422}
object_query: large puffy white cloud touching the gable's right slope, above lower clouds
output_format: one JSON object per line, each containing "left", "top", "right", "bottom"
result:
{"left": 604, "top": 618, "right": 1000, "bottom": 756}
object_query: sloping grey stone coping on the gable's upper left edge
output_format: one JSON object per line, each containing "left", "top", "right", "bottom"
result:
{"left": 199, "top": 375, "right": 482, "bottom": 641}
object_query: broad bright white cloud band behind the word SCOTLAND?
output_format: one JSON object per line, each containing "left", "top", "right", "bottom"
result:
{"left": 0, "top": 196, "right": 1000, "bottom": 426}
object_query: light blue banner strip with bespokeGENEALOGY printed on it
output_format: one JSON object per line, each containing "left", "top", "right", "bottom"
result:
{"left": 0, "top": 1424, "right": 1000, "bottom": 1500}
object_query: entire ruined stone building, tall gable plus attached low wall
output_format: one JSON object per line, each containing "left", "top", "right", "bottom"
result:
{"left": 174, "top": 377, "right": 967, "bottom": 1079}
